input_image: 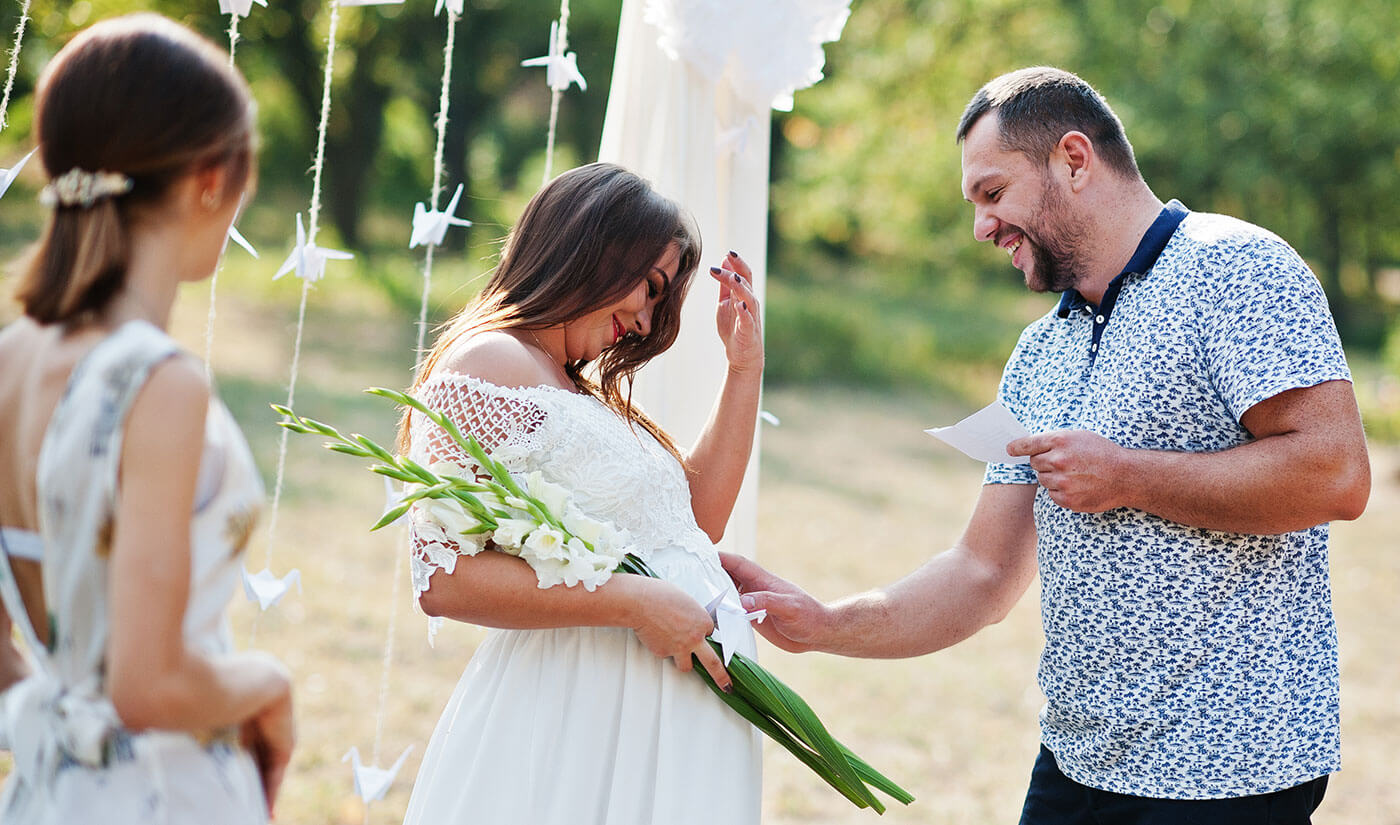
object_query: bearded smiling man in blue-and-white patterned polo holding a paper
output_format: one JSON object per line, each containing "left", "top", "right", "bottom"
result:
{"left": 725, "top": 67, "right": 1371, "bottom": 825}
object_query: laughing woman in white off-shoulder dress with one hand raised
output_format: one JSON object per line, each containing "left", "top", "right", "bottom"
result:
{"left": 394, "top": 164, "right": 763, "bottom": 825}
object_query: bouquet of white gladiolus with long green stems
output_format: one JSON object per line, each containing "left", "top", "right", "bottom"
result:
{"left": 272, "top": 388, "right": 914, "bottom": 814}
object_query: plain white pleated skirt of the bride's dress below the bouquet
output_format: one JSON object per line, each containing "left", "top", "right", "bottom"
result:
{"left": 405, "top": 628, "right": 762, "bottom": 825}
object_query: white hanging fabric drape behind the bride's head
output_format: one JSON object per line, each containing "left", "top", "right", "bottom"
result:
{"left": 598, "top": 0, "right": 850, "bottom": 556}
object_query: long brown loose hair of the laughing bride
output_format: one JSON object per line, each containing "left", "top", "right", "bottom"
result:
{"left": 398, "top": 164, "right": 700, "bottom": 459}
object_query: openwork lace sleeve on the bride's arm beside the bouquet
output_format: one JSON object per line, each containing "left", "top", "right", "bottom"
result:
{"left": 409, "top": 373, "right": 546, "bottom": 643}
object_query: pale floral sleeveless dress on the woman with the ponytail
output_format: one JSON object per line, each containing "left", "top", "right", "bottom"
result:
{"left": 0, "top": 321, "right": 267, "bottom": 825}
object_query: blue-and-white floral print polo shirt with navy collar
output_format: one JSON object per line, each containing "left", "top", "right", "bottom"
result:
{"left": 986, "top": 200, "right": 1351, "bottom": 798}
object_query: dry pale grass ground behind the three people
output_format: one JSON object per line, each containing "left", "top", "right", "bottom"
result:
{"left": 0, "top": 267, "right": 1400, "bottom": 825}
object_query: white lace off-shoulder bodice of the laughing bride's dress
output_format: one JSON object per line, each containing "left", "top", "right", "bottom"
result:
{"left": 409, "top": 371, "right": 724, "bottom": 602}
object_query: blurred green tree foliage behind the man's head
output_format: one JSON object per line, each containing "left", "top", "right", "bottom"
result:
{"left": 773, "top": 0, "right": 1400, "bottom": 346}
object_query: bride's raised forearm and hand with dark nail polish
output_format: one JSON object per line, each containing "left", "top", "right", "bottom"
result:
{"left": 686, "top": 252, "right": 763, "bottom": 542}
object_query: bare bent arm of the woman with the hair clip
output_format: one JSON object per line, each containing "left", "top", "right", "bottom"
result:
{"left": 106, "top": 359, "right": 291, "bottom": 804}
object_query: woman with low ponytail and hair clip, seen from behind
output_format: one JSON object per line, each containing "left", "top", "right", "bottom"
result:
{"left": 0, "top": 14, "right": 293, "bottom": 825}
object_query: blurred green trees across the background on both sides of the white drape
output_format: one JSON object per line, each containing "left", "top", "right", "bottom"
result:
{"left": 0, "top": 0, "right": 1400, "bottom": 420}
